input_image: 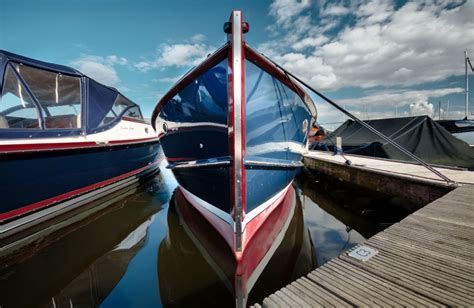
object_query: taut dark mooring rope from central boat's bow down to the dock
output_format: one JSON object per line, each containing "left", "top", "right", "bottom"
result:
{"left": 262, "top": 54, "right": 455, "bottom": 184}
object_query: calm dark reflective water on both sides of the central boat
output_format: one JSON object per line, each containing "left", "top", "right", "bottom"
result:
{"left": 0, "top": 164, "right": 407, "bottom": 308}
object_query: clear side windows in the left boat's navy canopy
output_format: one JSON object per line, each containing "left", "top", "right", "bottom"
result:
{"left": 0, "top": 63, "right": 81, "bottom": 129}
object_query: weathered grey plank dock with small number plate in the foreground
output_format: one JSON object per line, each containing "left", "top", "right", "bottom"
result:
{"left": 255, "top": 185, "right": 474, "bottom": 307}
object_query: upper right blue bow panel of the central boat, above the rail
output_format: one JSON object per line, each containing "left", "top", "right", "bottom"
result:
{"left": 245, "top": 60, "right": 311, "bottom": 159}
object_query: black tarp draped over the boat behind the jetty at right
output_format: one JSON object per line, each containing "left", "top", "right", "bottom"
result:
{"left": 315, "top": 116, "right": 474, "bottom": 170}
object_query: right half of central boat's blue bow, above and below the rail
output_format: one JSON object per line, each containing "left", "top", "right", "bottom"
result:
{"left": 245, "top": 60, "right": 311, "bottom": 212}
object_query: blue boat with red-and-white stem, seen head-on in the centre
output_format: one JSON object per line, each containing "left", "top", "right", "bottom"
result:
{"left": 152, "top": 11, "right": 316, "bottom": 306}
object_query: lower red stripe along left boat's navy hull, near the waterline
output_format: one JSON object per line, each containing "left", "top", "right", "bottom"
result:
{"left": 0, "top": 160, "right": 160, "bottom": 222}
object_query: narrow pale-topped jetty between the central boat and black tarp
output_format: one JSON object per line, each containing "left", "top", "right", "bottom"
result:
{"left": 304, "top": 151, "right": 474, "bottom": 209}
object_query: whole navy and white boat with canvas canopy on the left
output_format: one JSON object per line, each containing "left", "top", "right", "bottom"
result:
{"left": 0, "top": 51, "right": 159, "bottom": 239}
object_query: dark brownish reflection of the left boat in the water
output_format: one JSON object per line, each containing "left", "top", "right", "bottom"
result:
{"left": 0, "top": 174, "right": 171, "bottom": 307}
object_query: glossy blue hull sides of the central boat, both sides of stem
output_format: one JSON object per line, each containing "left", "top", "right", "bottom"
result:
{"left": 159, "top": 60, "right": 312, "bottom": 213}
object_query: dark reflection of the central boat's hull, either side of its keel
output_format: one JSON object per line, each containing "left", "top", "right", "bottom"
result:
{"left": 158, "top": 186, "right": 316, "bottom": 307}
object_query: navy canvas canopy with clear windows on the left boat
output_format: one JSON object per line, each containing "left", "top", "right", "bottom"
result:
{"left": 0, "top": 50, "right": 143, "bottom": 138}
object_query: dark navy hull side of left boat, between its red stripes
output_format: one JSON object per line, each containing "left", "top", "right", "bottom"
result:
{"left": 0, "top": 141, "right": 160, "bottom": 220}
